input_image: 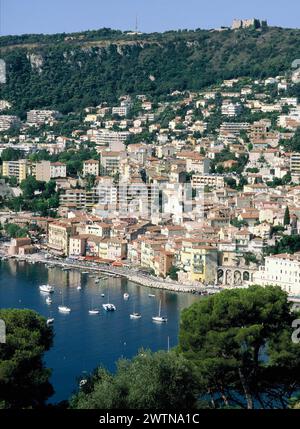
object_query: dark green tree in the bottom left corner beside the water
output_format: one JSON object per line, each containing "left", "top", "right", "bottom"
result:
{"left": 0, "top": 309, "right": 53, "bottom": 408}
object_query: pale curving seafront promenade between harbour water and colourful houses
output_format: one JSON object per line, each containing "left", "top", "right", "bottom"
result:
{"left": 0, "top": 253, "right": 218, "bottom": 294}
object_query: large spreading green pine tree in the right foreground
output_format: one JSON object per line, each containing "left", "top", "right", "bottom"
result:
{"left": 179, "top": 286, "right": 300, "bottom": 408}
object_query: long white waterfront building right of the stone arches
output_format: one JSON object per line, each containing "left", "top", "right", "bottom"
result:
{"left": 253, "top": 253, "right": 300, "bottom": 295}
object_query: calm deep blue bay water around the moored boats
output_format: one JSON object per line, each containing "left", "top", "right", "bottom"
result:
{"left": 0, "top": 260, "right": 199, "bottom": 402}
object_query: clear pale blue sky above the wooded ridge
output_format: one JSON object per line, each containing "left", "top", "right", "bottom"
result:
{"left": 0, "top": 0, "right": 300, "bottom": 35}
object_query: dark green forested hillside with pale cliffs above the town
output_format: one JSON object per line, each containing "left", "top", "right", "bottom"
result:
{"left": 0, "top": 28, "right": 300, "bottom": 114}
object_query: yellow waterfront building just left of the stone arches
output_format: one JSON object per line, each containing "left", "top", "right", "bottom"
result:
{"left": 176, "top": 239, "right": 218, "bottom": 284}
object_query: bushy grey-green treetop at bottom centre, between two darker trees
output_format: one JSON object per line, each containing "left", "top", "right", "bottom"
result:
{"left": 70, "top": 350, "right": 196, "bottom": 410}
